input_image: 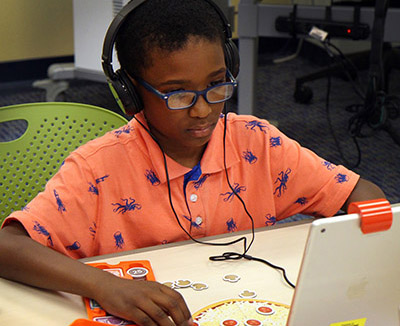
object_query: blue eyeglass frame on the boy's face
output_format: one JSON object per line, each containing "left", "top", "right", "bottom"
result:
{"left": 134, "top": 70, "right": 238, "bottom": 110}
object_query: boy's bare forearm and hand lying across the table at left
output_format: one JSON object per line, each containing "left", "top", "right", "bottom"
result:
{"left": 0, "top": 222, "right": 190, "bottom": 326}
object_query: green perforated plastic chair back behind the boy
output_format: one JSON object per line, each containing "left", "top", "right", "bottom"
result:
{"left": 0, "top": 102, "right": 128, "bottom": 224}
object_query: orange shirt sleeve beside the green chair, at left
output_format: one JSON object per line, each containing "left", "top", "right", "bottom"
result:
{"left": 3, "top": 153, "right": 98, "bottom": 258}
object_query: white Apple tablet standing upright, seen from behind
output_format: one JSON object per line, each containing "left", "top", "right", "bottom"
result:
{"left": 287, "top": 205, "right": 400, "bottom": 326}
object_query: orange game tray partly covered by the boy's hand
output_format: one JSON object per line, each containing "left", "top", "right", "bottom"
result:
{"left": 84, "top": 260, "right": 155, "bottom": 326}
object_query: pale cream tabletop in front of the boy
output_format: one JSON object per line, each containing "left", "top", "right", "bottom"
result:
{"left": 0, "top": 222, "right": 309, "bottom": 326}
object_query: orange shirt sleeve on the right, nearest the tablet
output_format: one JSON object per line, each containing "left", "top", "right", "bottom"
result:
{"left": 270, "top": 126, "right": 359, "bottom": 220}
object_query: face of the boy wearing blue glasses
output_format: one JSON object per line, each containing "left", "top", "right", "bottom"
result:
{"left": 135, "top": 37, "right": 226, "bottom": 166}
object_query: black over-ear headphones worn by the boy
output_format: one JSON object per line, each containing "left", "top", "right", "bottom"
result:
{"left": 102, "top": 0, "right": 240, "bottom": 115}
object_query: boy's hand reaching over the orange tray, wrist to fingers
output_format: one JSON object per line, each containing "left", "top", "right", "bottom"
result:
{"left": 94, "top": 272, "right": 193, "bottom": 326}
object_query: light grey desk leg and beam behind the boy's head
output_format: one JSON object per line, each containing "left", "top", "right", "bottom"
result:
{"left": 238, "top": 0, "right": 400, "bottom": 114}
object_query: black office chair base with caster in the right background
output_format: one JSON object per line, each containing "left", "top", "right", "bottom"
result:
{"left": 294, "top": 0, "right": 400, "bottom": 145}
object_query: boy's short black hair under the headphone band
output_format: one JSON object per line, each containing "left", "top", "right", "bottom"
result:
{"left": 115, "top": 0, "right": 225, "bottom": 76}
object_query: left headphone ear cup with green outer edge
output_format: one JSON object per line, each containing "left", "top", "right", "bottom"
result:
{"left": 109, "top": 69, "right": 143, "bottom": 115}
